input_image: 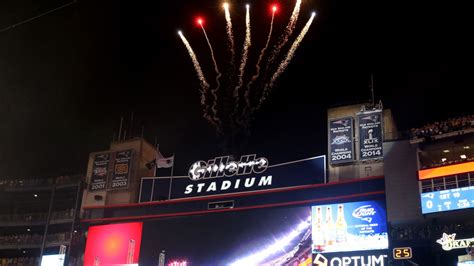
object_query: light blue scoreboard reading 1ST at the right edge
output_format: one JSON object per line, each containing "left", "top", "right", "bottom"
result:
{"left": 421, "top": 186, "right": 474, "bottom": 214}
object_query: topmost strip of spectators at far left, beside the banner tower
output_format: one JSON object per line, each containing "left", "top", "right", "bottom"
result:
{"left": 0, "top": 176, "right": 80, "bottom": 188}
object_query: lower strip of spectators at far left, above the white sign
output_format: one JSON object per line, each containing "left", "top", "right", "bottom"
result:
{"left": 0, "top": 232, "right": 69, "bottom": 246}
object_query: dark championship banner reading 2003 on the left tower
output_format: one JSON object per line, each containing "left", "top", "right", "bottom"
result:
{"left": 109, "top": 150, "right": 133, "bottom": 189}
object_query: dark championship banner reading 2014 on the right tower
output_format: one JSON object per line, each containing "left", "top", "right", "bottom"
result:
{"left": 357, "top": 111, "right": 383, "bottom": 160}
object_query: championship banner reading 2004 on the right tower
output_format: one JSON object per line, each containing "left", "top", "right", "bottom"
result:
{"left": 328, "top": 117, "right": 354, "bottom": 164}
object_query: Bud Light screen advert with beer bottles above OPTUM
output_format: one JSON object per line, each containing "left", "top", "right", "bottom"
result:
{"left": 311, "top": 200, "right": 388, "bottom": 253}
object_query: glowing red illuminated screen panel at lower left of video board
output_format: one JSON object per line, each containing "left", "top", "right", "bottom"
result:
{"left": 84, "top": 223, "right": 143, "bottom": 266}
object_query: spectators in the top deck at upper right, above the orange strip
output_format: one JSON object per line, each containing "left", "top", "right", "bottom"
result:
{"left": 411, "top": 115, "right": 474, "bottom": 139}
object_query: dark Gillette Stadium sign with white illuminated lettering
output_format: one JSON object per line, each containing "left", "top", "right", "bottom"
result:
{"left": 146, "top": 154, "right": 326, "bottom": 200}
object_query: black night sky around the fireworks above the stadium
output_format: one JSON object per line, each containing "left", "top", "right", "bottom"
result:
{"left": 0, "top": 0, "right": 473, "bottom": 177}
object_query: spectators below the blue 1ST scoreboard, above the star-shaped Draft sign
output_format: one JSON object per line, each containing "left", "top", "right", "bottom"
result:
{"left": 390, "top": 224, "right": 474, "bottom": 240}
